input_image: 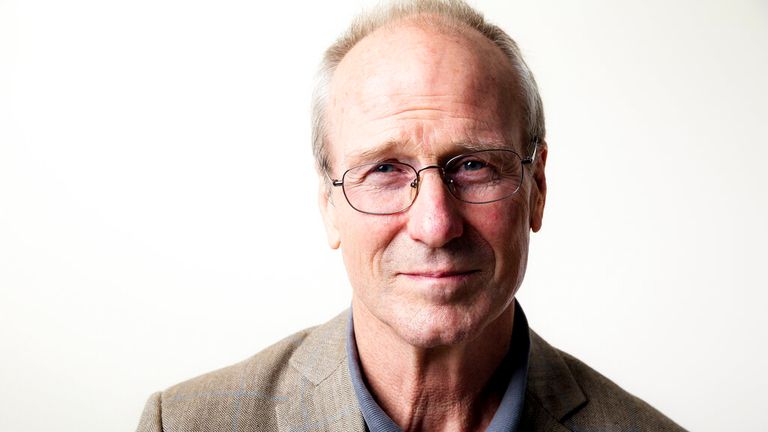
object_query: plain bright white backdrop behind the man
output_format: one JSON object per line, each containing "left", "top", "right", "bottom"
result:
{"left": 0, "top": 0, "right": 768, "bottom": 432}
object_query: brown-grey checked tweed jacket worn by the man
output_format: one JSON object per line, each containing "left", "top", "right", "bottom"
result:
{"left": 138, "top": 311, "right": 684, "bottom": 432}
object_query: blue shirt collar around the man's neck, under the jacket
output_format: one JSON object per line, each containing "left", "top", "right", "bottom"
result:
{"left": 347, "top": 300, "right": 531, "bottom": 432}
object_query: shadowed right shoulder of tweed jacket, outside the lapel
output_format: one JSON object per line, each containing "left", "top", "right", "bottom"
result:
{"left": 556, "top": 349, "right": 685, "bottom": 432}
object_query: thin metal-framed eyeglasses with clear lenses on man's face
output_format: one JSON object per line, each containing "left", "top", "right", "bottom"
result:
{"left": 331, "top": 148, "right": 536, "bottom": 215}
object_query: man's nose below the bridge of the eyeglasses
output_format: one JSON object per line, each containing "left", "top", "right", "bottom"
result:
{"left": 407, "top": 166, "right": 464, "bottom": 248}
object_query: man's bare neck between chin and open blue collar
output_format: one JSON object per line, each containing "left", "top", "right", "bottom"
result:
{"left": 352, "top": 300, "right": 515, "bottom": 431}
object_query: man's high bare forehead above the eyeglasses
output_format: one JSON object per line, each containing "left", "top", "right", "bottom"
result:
{"left": 328, "top": 22, "right": 523, "bottom": 168}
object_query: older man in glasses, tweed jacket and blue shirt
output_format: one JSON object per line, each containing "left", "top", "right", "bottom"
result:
{"left": 139, "top": 0, "right": 682, "bottom": 431}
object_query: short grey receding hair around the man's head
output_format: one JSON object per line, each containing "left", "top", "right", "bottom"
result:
{"left": 312, "top": 0, "right": 545, "bottom": 173}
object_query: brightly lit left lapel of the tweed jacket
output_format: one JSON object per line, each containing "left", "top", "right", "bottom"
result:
{"left": 275, "top": 311, "right": 365, "bottom": 432}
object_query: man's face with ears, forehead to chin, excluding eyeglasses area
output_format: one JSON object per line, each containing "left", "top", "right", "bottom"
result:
{"left": 321, "top": 24, "right": 546, "bottom": 347}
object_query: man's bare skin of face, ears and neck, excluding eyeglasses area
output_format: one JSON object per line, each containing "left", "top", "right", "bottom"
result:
{"left": 319, "top": 17, "right": 547, "bottom": 431}
